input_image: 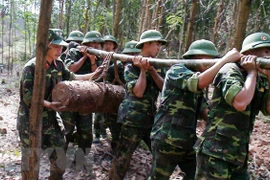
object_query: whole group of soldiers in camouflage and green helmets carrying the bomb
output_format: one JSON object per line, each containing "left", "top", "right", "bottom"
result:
{"left": 15, "top": 26, "right": 270, "bottom": 180}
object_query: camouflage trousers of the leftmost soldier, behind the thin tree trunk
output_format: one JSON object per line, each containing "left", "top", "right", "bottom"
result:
{"left": 17, "top": 111, "right": 66, "bottom": 180}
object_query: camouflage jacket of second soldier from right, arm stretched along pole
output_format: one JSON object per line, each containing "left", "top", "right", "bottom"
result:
{"left": 151, "top": 64, "right": 207, "bottom": 150}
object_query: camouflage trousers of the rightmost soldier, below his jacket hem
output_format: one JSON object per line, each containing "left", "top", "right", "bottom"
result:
{"left": 195, "top": 152, "right": 249, "bottom": 180}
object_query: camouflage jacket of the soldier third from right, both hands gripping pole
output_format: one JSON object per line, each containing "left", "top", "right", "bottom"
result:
{"left": 118, "top": 63, "right": 165, "bottom": 128}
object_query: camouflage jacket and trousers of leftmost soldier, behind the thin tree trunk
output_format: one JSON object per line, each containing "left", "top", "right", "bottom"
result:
{"left": 17, "top": 58, "right": 74, "bottom": 179}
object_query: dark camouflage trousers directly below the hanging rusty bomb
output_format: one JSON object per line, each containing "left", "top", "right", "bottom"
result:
{"left": 61, "top": 112, "right": 93, "bottom": 154}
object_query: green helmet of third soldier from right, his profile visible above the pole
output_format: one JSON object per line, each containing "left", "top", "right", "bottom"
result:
{"left": 136, "top": 30, "right": 167, "bottom": 49}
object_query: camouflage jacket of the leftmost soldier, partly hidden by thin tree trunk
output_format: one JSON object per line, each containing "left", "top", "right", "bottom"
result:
{"left": 17, "top": 58, "right": 74, "bottom": 130}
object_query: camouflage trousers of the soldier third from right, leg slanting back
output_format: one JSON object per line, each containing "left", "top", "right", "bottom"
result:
{"left": 109, "top": 125, "right": 151, "bottom": 180}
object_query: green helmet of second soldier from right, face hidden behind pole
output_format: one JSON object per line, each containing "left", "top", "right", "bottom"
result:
{"left": 182, "top": 39, "right": 219, "bottom": 58}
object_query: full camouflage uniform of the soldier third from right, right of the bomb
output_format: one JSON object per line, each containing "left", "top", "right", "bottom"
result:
{"left": 109, "top": 64, "right": 165, "bottom": 180}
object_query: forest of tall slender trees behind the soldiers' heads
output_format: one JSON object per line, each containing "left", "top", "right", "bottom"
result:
{"left": 0, "top": 0, "right": 270, "bottom": 73}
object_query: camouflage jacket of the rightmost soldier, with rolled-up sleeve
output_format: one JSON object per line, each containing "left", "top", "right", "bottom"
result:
{"left": 194, "top": 63, "right": 268, "bottom": 165}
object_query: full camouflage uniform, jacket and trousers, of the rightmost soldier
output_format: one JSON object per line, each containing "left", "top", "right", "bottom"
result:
{"left": 194, "top": 63, "right": 268, "bottom": 179}
